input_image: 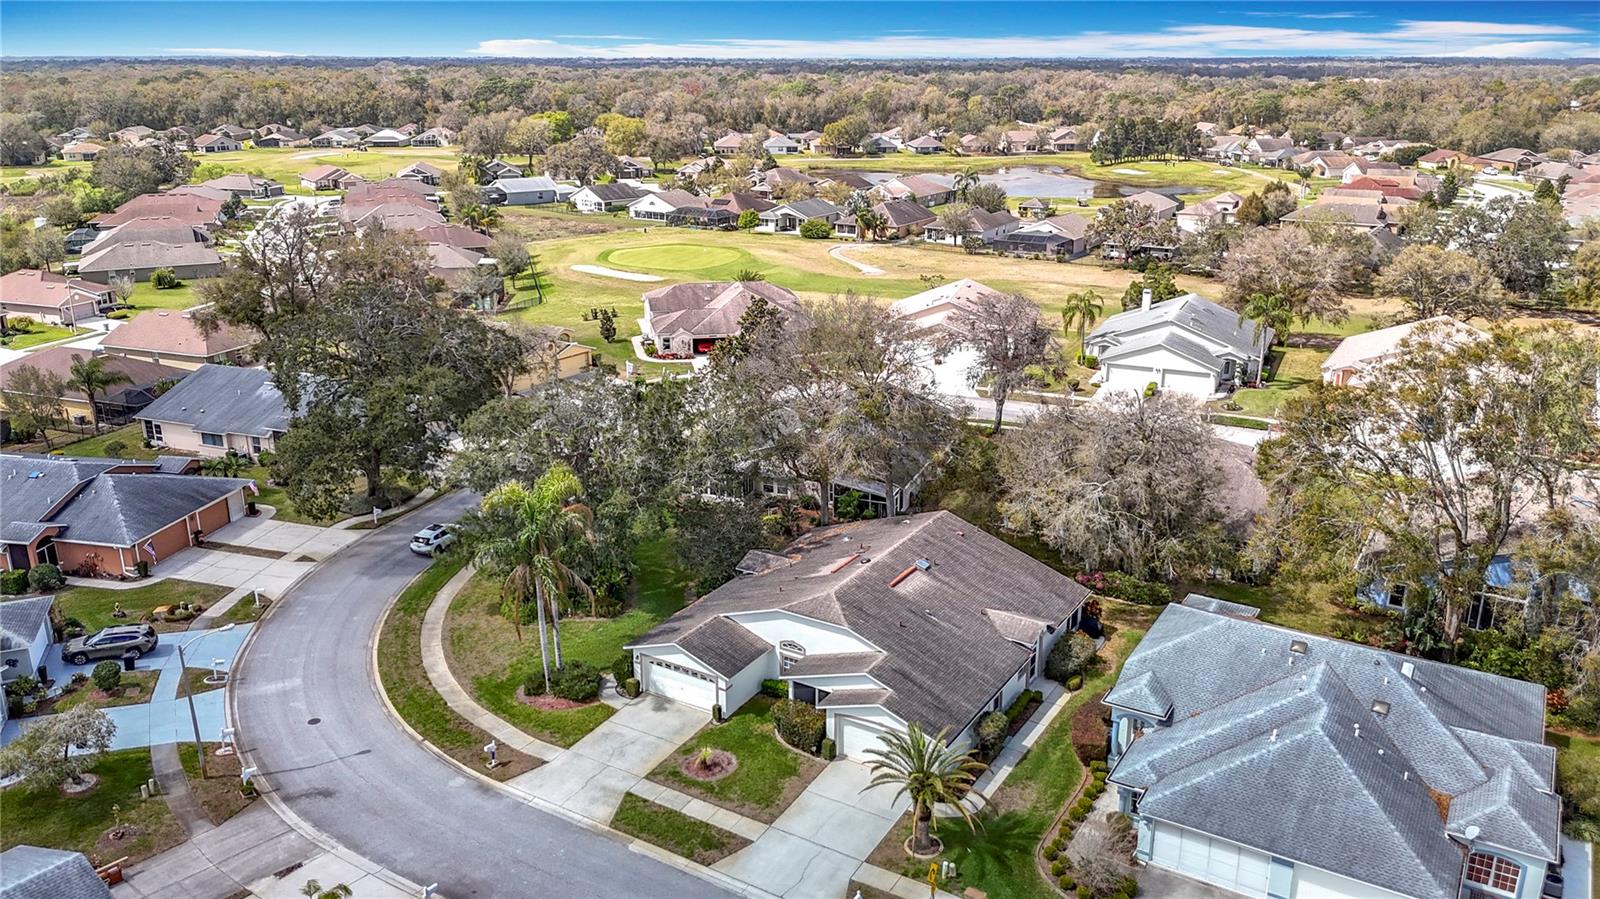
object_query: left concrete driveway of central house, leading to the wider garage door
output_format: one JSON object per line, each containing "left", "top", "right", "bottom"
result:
{"left": 509, "top": 693, "right": 710, "bottom": 824}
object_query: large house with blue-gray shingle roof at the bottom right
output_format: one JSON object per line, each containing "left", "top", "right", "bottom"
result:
{"left": 1104, "top": 595, "right": 1562, "bottom": 899}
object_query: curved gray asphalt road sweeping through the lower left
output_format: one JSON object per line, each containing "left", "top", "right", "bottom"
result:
{"left": 234, "top": 491, "right": 730, "bottom": 899}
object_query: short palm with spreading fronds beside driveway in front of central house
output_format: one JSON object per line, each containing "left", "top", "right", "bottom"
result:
{"left": 866, "top": 723, "right": 987, "bottom": 854}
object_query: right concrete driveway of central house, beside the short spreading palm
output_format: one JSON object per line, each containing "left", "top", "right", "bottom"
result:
{"left": 714, "top": 758, "right": 910, "bottom": 899}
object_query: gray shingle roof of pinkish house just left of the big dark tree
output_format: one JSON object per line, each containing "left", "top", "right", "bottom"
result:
{"left": 134, "top": 365, "right": 290, "bottom": 437}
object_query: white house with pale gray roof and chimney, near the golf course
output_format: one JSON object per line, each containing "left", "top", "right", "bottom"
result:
{"left": 1083, "top": 291, "right": 1274, "bottom": 400}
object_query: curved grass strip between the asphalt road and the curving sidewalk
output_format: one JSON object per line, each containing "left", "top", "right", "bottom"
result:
{"left": 378, "top": 558, "right": 534, "bottom": 781}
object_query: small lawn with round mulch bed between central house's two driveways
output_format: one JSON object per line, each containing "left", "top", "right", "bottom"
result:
{"left": 651, "top": 696, "right": 822, "bottom": 822}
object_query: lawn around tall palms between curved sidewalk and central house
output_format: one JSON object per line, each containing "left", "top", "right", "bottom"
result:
{"left": 445, "top": 537, "right": 688, "bottom": 745}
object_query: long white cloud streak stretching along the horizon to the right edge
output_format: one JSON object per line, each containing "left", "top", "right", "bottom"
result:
{"left": 470, "top": 21, "right": 1600, "bottom": 59}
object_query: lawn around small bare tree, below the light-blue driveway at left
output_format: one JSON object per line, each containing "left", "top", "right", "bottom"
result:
{"left": 0, "top": 749, "right": 184, "bottom": 865}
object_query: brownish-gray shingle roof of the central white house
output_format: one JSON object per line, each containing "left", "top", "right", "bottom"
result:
{"left": 638, "top": 512, "right": 1088, "bottom": 733}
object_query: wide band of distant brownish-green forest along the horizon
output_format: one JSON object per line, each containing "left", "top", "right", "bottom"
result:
{"left": 9, "top": 59, "right": 1600, "bottom": 152}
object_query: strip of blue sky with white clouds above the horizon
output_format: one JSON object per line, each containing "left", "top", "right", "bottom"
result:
{"left": 0, "top": 0, "right": 1600, "bottom": 59}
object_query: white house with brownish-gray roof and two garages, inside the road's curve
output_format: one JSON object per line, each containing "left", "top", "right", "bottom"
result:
{"left": 629, "top": 512, "right": 1088, "bottom": 760}
